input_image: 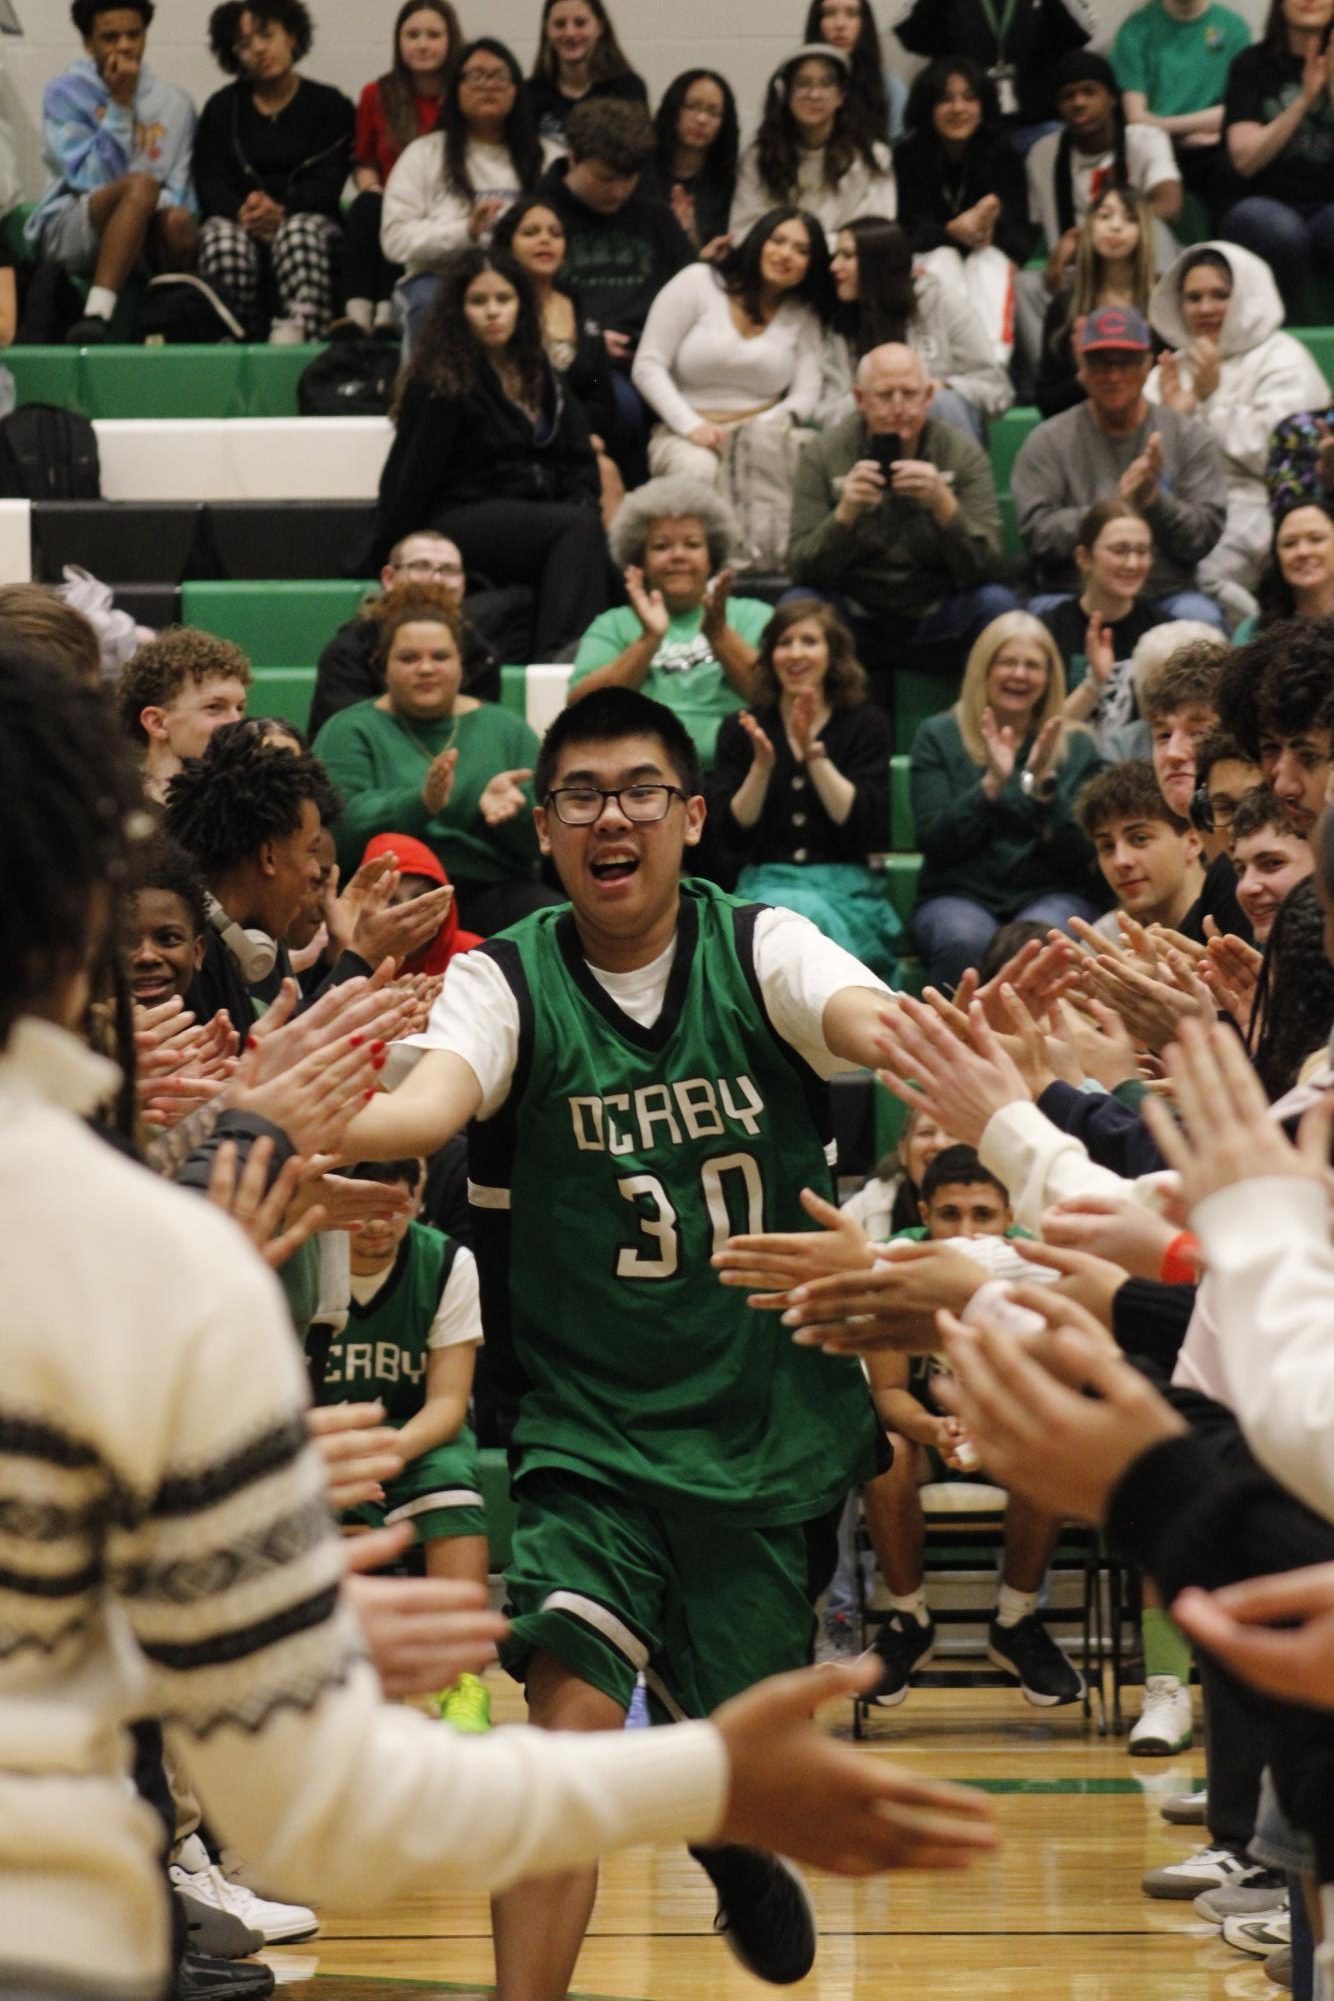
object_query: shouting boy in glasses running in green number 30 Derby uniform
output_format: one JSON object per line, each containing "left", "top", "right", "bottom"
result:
{"left": 348, "top": 688, "right": 912, "bottom": 2001}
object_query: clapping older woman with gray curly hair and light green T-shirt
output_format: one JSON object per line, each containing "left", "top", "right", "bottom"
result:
{"left": 570, "top": 476, "right": 774, "bottom": 766}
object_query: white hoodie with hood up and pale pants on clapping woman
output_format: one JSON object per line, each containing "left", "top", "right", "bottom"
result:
{"left": 1144, "top": 242, "right": 1330, "bottom": 590}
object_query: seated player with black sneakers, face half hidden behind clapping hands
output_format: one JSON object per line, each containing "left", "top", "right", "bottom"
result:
{"left": 862, "top": 1147, "right": 1084, "bottom": 1709}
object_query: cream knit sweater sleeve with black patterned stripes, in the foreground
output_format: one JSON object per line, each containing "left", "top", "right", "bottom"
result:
{"left": 108, "top": 1248, "right": 726, "bottom": 1907}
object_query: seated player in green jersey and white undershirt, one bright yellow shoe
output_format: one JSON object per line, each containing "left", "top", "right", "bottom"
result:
{"left": 318, "top": 1161, "right": 490, "bottom": 1731}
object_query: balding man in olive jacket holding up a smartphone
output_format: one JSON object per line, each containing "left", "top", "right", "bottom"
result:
{"left": 788, "top": 342, "right": 1018, "bottom": 668}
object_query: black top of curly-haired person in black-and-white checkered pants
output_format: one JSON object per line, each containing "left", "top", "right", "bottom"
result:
{"left": 194, "top": 76, "right": 356, "bottom": 222}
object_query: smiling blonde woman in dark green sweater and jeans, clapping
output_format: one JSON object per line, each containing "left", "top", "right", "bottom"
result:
{"left": 912, "top": 612, "right": 1102, "bottom": 986}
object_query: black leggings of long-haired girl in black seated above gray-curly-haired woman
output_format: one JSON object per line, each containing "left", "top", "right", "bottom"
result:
{"left": 430, "top": 500, "right": 608, "bottom": 660}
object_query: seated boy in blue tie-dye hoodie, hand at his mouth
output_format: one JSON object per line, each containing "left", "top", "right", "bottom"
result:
{"left": 24, "top": 0, "right": 198, "bottom": 346}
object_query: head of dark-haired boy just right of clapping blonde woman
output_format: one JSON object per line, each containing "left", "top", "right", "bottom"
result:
{"left": 1076, "top": 758, "right": 1204, "bottom": 944}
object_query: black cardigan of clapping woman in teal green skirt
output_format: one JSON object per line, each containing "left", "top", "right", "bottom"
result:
{"left": 706, "top": 702, "right": 894, "bottom": 866}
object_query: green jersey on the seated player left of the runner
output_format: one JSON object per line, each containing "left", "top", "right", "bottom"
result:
{"left": 318, "top": 1223, "right": 458, "bottom": 1425}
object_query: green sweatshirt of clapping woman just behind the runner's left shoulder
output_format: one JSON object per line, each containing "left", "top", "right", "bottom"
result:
{"left": 314, "top": 702, "right": 538, "bottom": 882}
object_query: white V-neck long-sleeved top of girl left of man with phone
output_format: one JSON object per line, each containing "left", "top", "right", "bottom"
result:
{"left": 630, "top": 264, "right": 820, "bottom": 438}
